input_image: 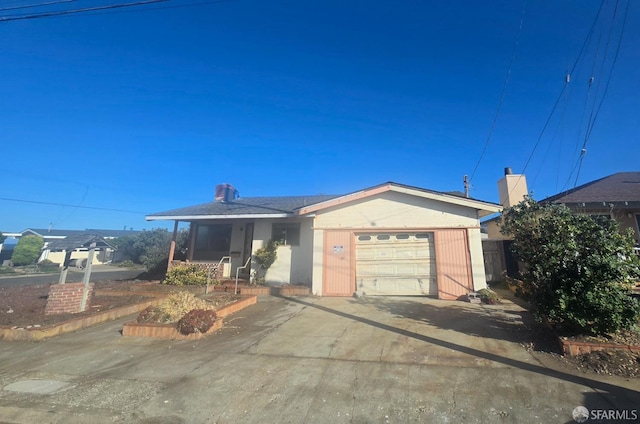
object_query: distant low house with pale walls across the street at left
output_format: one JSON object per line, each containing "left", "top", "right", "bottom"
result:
{"left": 21, "top": 228, "right": 140, "bottom": 266}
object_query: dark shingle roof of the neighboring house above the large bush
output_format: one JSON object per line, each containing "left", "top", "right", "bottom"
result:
{"left": 541, "top": 172, "right": 640, "bottom": 203}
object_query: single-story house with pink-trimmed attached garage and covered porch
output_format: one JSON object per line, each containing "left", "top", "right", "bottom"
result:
{"left": 147, "top": 182, "right": 501, "bottom": 299}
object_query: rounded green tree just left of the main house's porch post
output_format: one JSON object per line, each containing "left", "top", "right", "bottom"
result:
{"left": 113, "top": 228, "right": 189, "bottom": 269}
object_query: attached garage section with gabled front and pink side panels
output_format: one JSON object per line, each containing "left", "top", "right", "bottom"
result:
{"left": 300, "top": 183, "right": 500, "bottom": 299}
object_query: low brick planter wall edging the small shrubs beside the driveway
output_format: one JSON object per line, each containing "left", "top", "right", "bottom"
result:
{"left": 122, "top": 296, "right": 258, "bottom": 340}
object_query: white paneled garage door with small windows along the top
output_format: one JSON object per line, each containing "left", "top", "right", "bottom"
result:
{"left": 356, "top": 232, "right": 438, "bottom": 296}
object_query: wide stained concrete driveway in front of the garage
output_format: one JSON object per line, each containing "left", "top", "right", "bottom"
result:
{"left": 0, "top": 297, "right": 640, "bottom": 424}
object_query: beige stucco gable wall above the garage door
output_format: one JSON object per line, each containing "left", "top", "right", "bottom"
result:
{"left": 314, "top": 192, "right": 479, "bottom": 230}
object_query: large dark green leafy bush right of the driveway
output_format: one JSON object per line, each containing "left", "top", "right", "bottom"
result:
{"left": 501, "top": 199, "right": 640, "bottom": 334}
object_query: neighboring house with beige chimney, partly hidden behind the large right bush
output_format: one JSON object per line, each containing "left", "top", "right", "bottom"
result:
{"left": 482, "top": 172, "right": 640, "bottom": 281}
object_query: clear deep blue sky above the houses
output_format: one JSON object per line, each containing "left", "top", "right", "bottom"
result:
{"left": 0, "top": 0, "right": 640, "bottom": 232}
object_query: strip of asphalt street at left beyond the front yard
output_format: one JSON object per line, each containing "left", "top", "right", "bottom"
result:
{"left": 0, "top": 266, "right": 143, "bottom": 287}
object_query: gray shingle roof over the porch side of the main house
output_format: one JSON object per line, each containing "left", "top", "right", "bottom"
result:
{"left": 148, "top": 195, "right": 339, "bottom": 217}
